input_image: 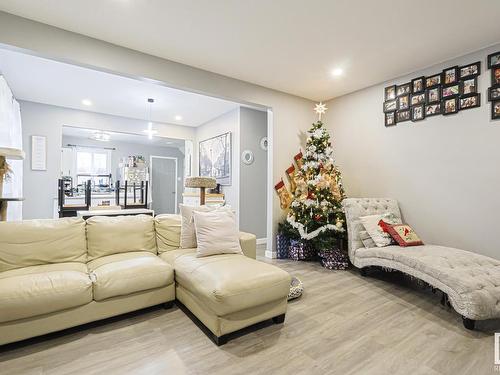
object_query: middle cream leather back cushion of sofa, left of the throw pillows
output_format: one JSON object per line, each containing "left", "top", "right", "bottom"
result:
{"left": 87, "top": 215, "right": 156, "bottom": 261}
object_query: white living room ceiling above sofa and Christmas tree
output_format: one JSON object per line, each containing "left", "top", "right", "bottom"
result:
{"left": 0, "top": 0, "right": 500, "bottom": 100}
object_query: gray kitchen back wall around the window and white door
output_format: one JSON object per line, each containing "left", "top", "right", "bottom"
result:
{"left": 62, "top": 136, "right": 184, "bottom": 213}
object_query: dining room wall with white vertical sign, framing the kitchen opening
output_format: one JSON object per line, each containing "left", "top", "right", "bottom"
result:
{"left": 20, "top": 101, "right": 194, "bottom": 219}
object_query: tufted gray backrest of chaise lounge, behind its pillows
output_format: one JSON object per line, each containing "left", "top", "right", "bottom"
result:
{"left": 342, "top": 198, "right": 401, "bottom": 261}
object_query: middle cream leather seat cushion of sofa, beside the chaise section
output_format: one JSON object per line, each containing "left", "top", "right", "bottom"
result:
{"left": 87, "top": 251, "right": 174, "bottom": 301}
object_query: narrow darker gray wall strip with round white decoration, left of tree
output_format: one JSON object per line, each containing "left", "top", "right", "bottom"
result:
{"left": 239, "top": 107, "right": 268, "bottom": 238}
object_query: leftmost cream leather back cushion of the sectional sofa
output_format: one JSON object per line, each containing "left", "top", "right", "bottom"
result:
{"left": 0, "top": 218, "right": 87, "bottom": 272}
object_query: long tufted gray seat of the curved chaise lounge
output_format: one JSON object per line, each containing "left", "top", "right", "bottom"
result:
{"left": 354, "top": 245, "right": 500, "bottom": 319}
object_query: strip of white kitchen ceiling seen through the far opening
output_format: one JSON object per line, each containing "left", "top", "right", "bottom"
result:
{"left": 62, "top": 126, "right": 185, "bottom": 149}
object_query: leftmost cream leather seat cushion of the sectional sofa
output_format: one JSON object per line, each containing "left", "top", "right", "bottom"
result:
{"left": 0, "top": 263, "right": 92, "bottom": 322}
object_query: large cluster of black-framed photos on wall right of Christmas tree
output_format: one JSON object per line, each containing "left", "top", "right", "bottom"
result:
{"left": 383, "top": 60, "right": 482, "bottom": 127}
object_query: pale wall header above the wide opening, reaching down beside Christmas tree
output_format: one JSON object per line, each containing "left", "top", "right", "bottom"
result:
{"left": 0, "top": 12, "right": 315, "bottom": 254}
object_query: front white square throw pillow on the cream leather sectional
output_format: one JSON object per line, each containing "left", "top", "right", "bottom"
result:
{"left": 193, "top": 210, "right": 243, "bottom": 257}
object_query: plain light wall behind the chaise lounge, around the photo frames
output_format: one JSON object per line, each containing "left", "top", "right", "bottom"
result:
{"left": 325, "top": 44, "right": 500, "bottom": 259}
